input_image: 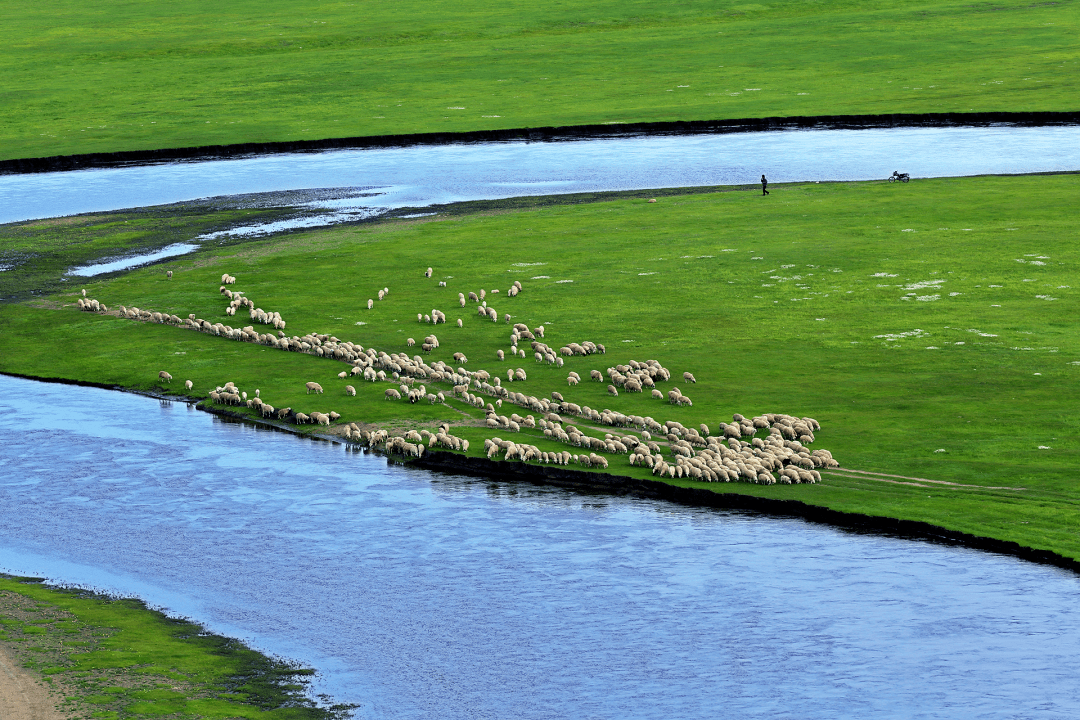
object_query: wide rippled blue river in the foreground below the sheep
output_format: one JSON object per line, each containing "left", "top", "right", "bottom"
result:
{"left": 0, "top": 376, "right": 1080, "bottom": 720}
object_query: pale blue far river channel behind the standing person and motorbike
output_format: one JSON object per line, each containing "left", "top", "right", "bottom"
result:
{"left": 0, "top": 126, "right": 1080, "bottom": 222}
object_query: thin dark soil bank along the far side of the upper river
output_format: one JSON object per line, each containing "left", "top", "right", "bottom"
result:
{"left": 8, "top": 111, "right": 1080, "bottom": 174}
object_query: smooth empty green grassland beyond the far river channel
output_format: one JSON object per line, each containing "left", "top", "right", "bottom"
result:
{"left": 0, "top": 0, "right": 1080, "bottom": 160}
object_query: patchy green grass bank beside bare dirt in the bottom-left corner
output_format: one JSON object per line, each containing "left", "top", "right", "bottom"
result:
{"left": 0, "top": 575, "right": 348, "bottom": 719}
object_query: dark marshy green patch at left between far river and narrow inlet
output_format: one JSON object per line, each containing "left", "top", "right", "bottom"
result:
{"left": 0, "top": 203, "right": 289, "bottom": 302}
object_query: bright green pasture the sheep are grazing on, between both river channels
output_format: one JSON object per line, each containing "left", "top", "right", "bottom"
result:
{"left": 0, "top": 174, "right": 1080, "bottom": 558}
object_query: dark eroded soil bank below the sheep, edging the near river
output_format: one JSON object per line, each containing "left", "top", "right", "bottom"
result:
{"left": 6, "top": 372, "right": 1080, "bottom": 573}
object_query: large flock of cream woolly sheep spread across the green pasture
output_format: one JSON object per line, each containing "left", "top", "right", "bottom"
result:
{"left": 78, "top": 268, "right": 838, "bottom": 485}
